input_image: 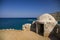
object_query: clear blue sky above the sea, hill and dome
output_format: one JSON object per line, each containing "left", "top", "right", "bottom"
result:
{"left": 0, "top": 0, "right": 60, "bottom": 18}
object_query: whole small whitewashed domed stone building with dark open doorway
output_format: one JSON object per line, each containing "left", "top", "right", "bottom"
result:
{"left": 31, "top": 13, "right": 57, "bottom": 36}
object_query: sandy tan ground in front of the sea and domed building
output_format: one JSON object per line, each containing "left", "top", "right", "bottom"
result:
{"left": 0, "top": 30, "right": 57, "bottom": 40}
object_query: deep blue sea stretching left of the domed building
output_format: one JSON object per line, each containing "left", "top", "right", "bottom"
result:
{"left": 0, "top": 18, "right": 36, "bottom": 30}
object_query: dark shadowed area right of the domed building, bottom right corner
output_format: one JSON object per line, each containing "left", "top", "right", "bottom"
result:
{"left": 49, "top": 25, "right": 60, "bottom": 40}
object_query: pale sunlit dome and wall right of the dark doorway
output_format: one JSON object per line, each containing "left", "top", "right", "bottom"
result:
{"left": 38, "top": 14, "right": 57, "bottom": 36}
